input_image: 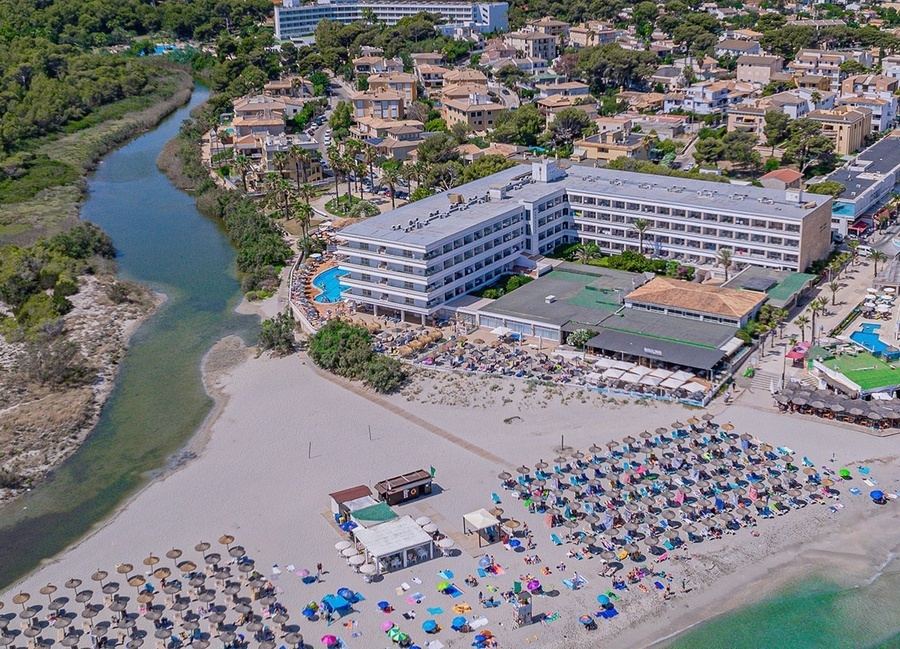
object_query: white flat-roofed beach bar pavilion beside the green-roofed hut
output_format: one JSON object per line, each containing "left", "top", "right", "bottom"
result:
{"left": 353, "top": 516, "right": 434, "bottom": 575}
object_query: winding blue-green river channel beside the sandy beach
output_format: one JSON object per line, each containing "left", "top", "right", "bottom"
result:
{"left": 0, "top": 86, "right": 258, "bottom": 587}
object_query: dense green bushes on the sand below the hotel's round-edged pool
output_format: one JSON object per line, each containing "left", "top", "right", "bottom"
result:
{"left": 309, "top": 320, "right": 408, "bottom": 393}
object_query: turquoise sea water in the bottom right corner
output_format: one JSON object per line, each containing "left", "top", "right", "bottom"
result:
{"left": 661, "top": 561, "right": 900, "bottom": 649}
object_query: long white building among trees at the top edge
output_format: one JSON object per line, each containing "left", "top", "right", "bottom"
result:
{"left": 275, "top": 0, "right": 509, "bottom": 40}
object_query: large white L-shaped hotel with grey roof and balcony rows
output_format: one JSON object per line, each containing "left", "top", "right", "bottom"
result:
{"left": 338, "top": 161, "right": 832, "bottom": 321}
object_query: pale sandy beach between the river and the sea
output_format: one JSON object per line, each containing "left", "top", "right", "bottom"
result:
{"left": 0, "top": 350, "right": 900, "bottom": 648}
